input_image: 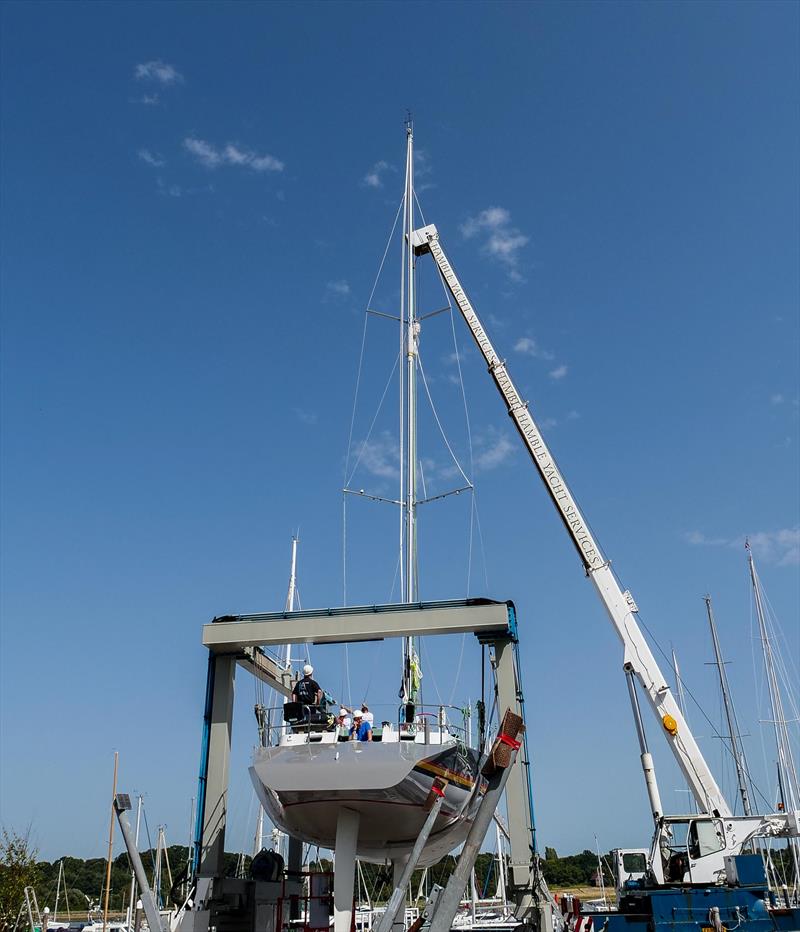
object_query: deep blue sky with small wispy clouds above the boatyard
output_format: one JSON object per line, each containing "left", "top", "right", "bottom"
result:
{"left": 0, "top": 3, "right": 800, "bottom": 857}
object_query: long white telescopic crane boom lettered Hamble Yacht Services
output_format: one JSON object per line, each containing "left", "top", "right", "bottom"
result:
{"left": 412, "top": 224, "right": 731, "bottom": 817}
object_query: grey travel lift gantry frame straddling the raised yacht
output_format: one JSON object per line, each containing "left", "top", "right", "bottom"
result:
{"left": 194, "top": 599, "right": 549, "bottom": 928}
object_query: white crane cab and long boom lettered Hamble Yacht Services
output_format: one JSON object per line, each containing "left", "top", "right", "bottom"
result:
{"left": 411, "top": 224, "right": 800, "bottom": 884}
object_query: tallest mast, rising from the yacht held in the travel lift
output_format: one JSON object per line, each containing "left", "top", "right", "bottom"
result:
{"left": 401, "top": 119, "right": 419, "bottom": 702}
